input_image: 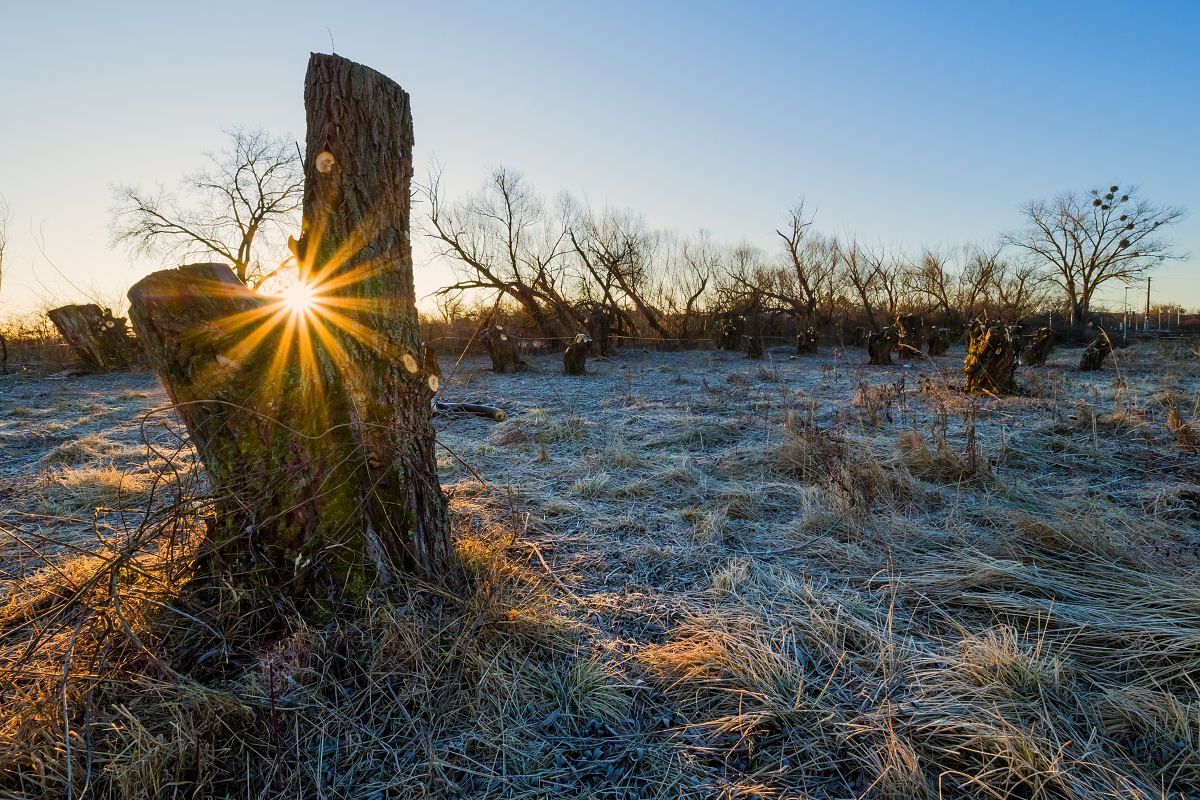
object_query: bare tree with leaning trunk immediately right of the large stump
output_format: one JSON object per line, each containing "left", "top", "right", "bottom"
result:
{"left": 420, "top": 167, "right": 580, "bottom": 336}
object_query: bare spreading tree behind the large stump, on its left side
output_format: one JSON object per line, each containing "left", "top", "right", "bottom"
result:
{"left": 109, "top": 127, "right": 304, "bottom": 288}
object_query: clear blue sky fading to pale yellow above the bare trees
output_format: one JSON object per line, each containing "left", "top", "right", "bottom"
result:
{"left": 0, "top": 0, "right": 1200, "bottom": 313}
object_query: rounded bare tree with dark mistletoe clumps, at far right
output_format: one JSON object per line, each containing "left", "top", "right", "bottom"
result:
{"left": 1003, "top": 186, "right": 1184, "bottom": 325}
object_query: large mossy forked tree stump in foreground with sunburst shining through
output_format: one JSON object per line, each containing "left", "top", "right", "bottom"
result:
{"left": 130, "top": 54, "right": 454, "bottom": 599}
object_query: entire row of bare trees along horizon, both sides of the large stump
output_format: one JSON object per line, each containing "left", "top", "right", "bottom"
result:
{"left": 100, "top": 128, "right": 1183, "bottom": 343}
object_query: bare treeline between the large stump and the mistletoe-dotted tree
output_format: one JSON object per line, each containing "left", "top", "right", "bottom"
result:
{"left": 424, "top": 168, "right": 1057, "bottom": 347}
